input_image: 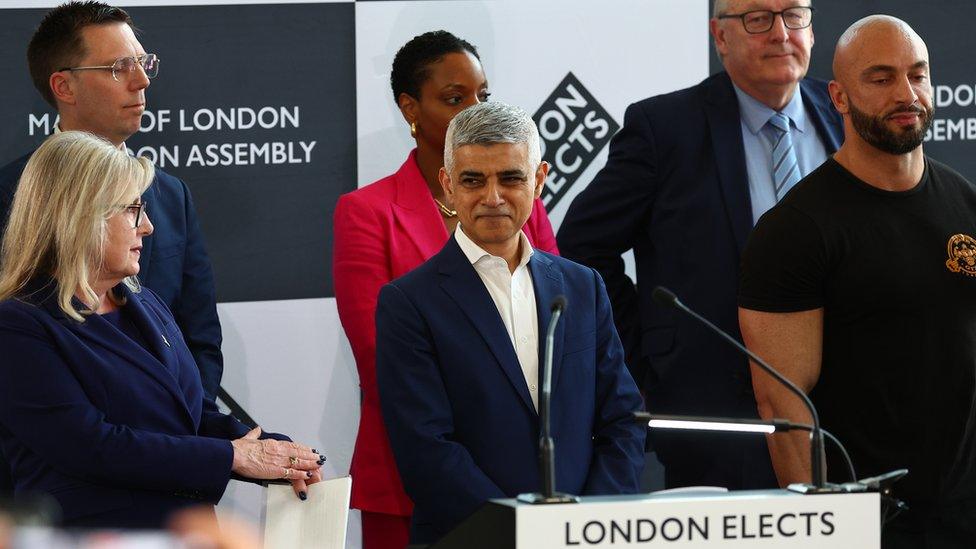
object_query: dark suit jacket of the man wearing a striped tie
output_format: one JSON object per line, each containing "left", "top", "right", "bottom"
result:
{"left": 558, "top": 72, "right": 843, "bottom": 488}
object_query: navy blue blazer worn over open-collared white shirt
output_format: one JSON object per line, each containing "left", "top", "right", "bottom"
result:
{"left": 376, "top": 237, "right": 645, "bottom": 543}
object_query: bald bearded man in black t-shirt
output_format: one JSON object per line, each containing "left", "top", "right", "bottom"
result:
{"left": 739, "top": 16, "right": 976, "bottom": 549}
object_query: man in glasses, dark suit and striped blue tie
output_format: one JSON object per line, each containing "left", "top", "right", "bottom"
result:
{"left": 558, "top": 0, "right": 843, "bottom": 489}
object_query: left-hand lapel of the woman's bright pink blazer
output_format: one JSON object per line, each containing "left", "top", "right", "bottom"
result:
{"left": 392, "top": 150, "right": 448, "bottom": 260}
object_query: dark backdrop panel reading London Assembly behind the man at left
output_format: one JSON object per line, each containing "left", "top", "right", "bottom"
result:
{"left": 0, "top": 3, "right": 356, "bottom": 302}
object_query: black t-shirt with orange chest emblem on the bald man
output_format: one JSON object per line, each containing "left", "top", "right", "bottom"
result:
{"left": 739, "top": 158, "right": 976, "bottom": 511}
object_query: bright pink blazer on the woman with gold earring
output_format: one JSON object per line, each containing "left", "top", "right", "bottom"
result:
{"left": 332, "top": 150, "right": 559, "bottom": 516}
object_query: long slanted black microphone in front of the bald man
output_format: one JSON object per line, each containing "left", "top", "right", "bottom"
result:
{"left": 651, "top": 286, "right": 829, "bottom": 492}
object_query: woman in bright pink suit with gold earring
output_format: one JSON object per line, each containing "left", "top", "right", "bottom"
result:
{"left": 332, "top": 31, "right": 558, "bottom": 549}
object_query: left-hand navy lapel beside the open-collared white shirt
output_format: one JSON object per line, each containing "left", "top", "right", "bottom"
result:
{"left": 437, "top": 236, "right": 536, "bottom": 414}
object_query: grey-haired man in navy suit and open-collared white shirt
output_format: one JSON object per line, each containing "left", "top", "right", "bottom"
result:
{"left": 376, "top": 103, "right": 645, "bottom": 543}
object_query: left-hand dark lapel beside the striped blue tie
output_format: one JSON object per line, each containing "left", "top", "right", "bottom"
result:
{"left": 705, "top": 73, "right": 752, "bottom": 254}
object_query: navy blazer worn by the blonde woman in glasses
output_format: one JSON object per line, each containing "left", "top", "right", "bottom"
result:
{"left": 0, "top": 283, "right": 248, "bottom": 528}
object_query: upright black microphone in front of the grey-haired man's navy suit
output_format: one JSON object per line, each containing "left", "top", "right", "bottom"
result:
{"left": 518, "top": 295, "right": 579, "bottom": 504}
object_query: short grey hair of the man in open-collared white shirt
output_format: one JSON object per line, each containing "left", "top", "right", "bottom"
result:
{"left": 444, "top": 101, "right": 542, "bottom": 174}
